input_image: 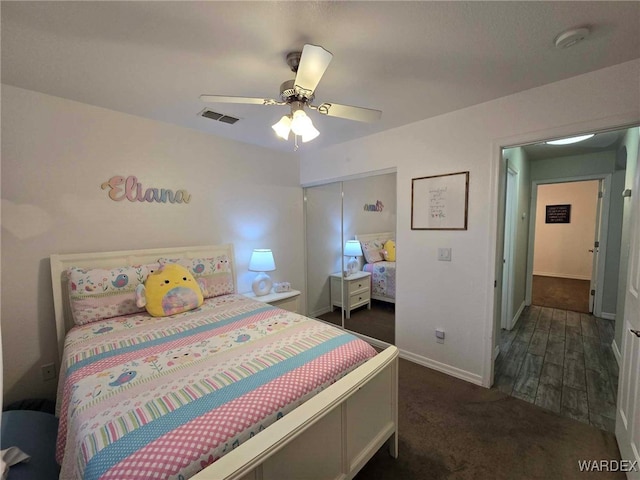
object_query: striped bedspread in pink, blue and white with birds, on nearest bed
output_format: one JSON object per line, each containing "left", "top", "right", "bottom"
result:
{"left": 56, "top": 295, "right": 376, "bottom": 480}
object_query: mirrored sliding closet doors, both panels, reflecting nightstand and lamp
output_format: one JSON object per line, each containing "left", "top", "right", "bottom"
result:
{"left": 305, "top": 173, "right": 396, "bottom": 344}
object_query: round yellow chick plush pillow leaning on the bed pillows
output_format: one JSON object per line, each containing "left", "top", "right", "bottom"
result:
{"left": 136, "top": 263, "right": 204, "bottom": 317}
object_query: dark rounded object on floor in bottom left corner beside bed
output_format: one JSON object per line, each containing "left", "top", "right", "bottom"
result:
{"left": 0, "top": 410, "right": 60, "bottom": 480}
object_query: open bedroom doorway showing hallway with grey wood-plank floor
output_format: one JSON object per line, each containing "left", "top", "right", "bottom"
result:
{"left": 493, "top": 129, "right": 627, "bottom": 431}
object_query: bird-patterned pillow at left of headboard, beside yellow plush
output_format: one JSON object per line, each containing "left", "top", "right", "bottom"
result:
{"left": 67, "top": 264, "right": 160, "bottom": 325}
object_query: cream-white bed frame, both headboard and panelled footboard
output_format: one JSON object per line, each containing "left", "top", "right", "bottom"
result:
{"left": 50, "top": 244, "right": 398, "bottom": 480}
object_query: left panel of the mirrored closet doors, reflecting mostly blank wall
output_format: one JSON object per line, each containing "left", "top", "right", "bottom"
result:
{"left": 304, "top": 182, "right": 343, "bottom": 327}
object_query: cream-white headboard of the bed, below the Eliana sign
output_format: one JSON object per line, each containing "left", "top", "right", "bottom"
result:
{"left": 50, "top": 243, "right": 237, "bottom": 358}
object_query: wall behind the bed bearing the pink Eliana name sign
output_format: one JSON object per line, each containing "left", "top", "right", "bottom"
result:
{"left": 1, "top": 85, "right": 304, "bottom": 403}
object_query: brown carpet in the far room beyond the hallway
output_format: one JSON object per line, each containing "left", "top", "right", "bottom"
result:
{"left": 531, "top": 275, "right": 590, "bottom": 313}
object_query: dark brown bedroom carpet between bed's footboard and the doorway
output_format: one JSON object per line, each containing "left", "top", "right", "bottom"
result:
{"left": 355, "top": 359, "right": 625, "bottom": 480}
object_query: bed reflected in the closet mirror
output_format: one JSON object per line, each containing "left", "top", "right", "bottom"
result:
{"left": 355, "top": 232, "right": 396, "bottom": 303}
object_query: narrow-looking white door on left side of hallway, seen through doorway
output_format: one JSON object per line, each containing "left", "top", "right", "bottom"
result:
{"left": 501, "top": 167, "right": 518, "bottom": 330}
